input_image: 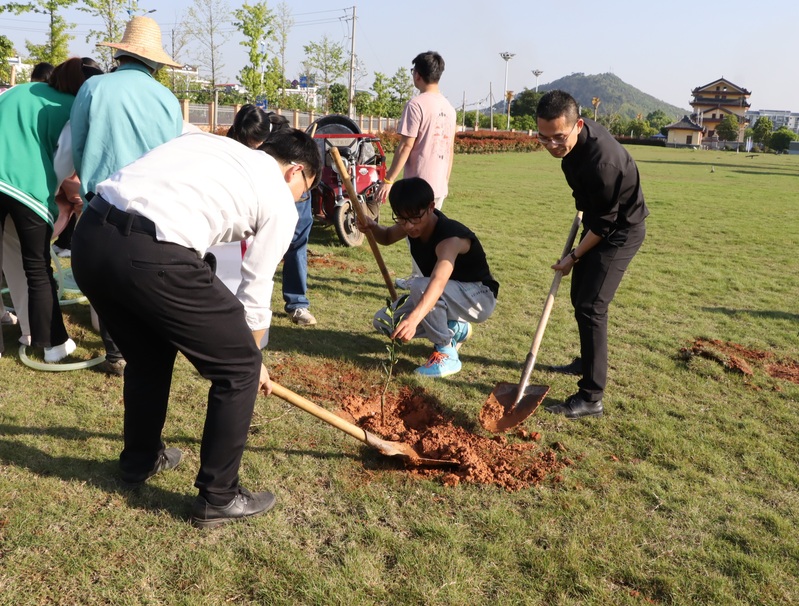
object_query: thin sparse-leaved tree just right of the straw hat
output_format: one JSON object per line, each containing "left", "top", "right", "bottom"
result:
{"left": 183, "top": 0, "right": 230, "bottom": 90}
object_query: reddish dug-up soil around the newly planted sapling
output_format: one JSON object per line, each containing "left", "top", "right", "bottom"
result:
{"left": 275, "top": 368, "right": 574, "bottom": 491}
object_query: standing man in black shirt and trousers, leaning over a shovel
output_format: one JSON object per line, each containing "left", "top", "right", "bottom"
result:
{"left": 537, "top": 90, "right": 649, "bottom": 419}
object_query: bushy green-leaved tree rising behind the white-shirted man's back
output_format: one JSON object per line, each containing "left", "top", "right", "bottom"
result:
{"left": 233, "top": 1, "right": 276, "bottom": 100}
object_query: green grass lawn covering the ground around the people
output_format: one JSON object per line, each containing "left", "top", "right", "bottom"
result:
{"left": 0, "top": 147, "right": 799, "bottom": 606}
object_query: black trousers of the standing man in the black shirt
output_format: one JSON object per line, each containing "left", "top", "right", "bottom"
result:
{"left": 571, "top": 222, "right": 646, "bottom": 402}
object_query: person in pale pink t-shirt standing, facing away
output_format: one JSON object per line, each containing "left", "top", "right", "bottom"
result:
{"left": 377, "top": 51, "right": 457, "bottom": 210}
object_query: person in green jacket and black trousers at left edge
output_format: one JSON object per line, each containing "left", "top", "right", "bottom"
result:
{"left": 0, "top": 58, "right": 93, "bottom": 362}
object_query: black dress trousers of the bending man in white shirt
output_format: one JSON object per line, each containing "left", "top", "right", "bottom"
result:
{"left": 72, "top": 198, "right": 262, "bottom": 502}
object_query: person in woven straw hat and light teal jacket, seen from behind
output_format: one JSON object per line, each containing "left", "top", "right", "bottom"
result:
{"left": 70, "top": 17, "right": 183, "bottom": 375}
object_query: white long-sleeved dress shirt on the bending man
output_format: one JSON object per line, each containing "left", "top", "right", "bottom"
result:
{"left": 97, "top": 132, "right": 298, "bottom": 330}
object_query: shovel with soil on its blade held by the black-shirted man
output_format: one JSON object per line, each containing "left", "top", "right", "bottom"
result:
{"left": 480, "top": 211, "right": 583, "bottom": 433}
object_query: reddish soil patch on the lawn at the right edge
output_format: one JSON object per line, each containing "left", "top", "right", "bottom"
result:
{"left": 680, "top": 337, "right": 799, "bottom": 384}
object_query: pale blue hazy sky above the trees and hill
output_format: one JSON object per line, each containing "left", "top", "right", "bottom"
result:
{"left": 0, "top": 0, "right": 799, "bottom": 112}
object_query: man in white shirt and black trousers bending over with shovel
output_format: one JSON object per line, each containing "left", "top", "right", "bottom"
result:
{"left": 72, "top": 129, "right": 321, "bottom": 528}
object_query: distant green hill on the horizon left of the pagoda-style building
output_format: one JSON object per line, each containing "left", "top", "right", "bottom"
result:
{"left": 498, "top": 73, "right": 691, "bottom": 122}
